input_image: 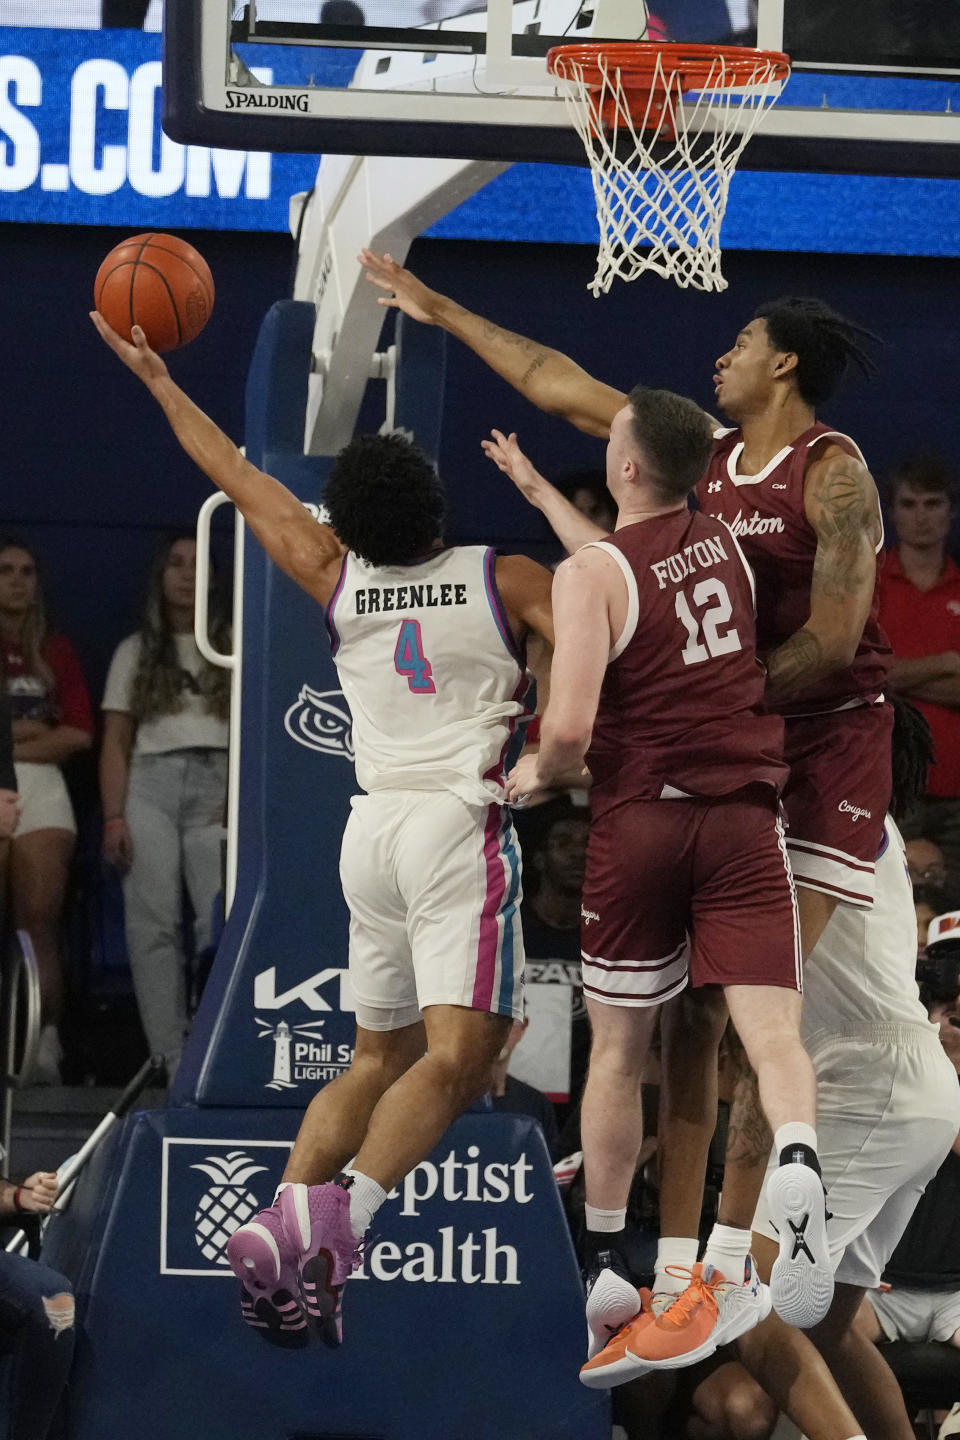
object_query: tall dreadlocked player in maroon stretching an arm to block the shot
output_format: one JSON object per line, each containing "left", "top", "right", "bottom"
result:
{"left": 361, "top": 251, "right": 891, "bottom": 1359}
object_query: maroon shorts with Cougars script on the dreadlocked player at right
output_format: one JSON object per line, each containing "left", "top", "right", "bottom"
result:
{"left": 783, "top": 704, "right": 894, "bottom": 906}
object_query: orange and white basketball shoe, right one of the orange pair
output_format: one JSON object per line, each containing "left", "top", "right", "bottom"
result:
{"left": 628, "top": 1256, "right": 770, "bottom": 1369}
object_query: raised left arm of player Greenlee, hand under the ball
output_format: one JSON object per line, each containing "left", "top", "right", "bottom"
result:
{"left": 91, "top": 311, "right": 343, "bottom": 605}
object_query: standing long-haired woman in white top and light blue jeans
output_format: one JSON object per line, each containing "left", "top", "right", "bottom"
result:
{"left": 99, "top": 536, "right": 230, "bottom": 1081}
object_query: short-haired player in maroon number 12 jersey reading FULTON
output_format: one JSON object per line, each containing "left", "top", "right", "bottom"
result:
{"left": 499, "top": 387, "right": 833, "bottom": 1387}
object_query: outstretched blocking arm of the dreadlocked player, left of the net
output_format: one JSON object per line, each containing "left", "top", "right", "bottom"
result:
{"left": 357, "top": 249, "right": 626, "bottom": 436}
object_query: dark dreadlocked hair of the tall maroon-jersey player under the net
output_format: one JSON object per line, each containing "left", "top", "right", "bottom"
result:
{"left": 753, "top": 295, "right": 879, "bottom": 406}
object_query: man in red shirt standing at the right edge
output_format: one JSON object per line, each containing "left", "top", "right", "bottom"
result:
{"left": 879, "top": 454, "right": 960, "bottom": 873}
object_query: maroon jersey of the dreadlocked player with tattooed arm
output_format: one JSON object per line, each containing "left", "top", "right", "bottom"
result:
{"left": 697, "top": 422, "right": 892, "bottom": 716}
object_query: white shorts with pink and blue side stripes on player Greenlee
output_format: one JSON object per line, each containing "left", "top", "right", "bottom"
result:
{"left": 340, "top": 791, "right": 524, "bottom": 1030}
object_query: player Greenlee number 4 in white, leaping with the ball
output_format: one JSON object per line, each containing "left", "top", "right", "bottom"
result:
{"left": 92, "top": 314, "right": 553, "bottom": 1344}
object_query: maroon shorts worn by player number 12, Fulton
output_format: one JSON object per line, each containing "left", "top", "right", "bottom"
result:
{"left": 580, "top": 786, "right": 800, "bottom": 1005}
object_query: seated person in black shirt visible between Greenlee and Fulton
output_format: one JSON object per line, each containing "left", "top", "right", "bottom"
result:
{"left": 512, "top": 795, "right": 590, "bottom": 1128}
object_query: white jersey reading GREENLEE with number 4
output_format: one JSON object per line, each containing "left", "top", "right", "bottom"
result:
{"left": 327, "top": 546, "right": 527, "bottom": 805}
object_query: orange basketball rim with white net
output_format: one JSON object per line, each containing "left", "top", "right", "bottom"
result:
{"left": 547, "top": 40, "right": 790, "bottom": 295}
